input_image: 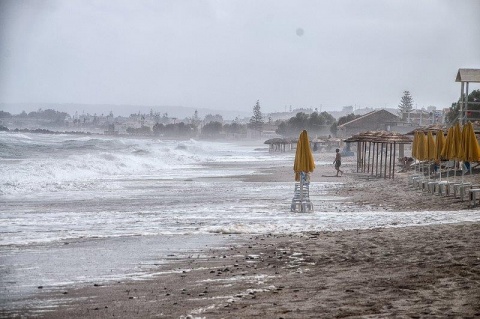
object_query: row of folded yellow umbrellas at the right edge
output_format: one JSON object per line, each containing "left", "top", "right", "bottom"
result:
{"left": 412, "top": 122, "right": 480, "bottom": 162}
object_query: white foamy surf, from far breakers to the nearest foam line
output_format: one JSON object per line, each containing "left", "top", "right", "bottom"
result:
{"left": 0, "top": 134, "right": 479, "bottom": 245}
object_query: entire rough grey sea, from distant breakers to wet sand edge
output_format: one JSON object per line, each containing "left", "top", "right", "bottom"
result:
{"left": 0, "top": 132, "right": 480, "bottom": 311}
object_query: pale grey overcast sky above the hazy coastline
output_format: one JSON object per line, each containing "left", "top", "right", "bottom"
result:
{"left": 0, "top": 0, "right": 480, "bottom": 117}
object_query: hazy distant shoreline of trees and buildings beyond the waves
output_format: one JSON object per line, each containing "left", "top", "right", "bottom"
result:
{"left": 0, "top": 100, "right": 344, "bottom": 139}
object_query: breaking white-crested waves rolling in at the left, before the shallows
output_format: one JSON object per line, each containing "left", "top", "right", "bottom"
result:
{"left": 0, "top": 134, "right": 274, "bottom": 195}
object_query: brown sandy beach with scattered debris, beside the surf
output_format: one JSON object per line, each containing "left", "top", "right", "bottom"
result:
{"left": 5, "top": 154, "right": 480, "bottom": 318}
